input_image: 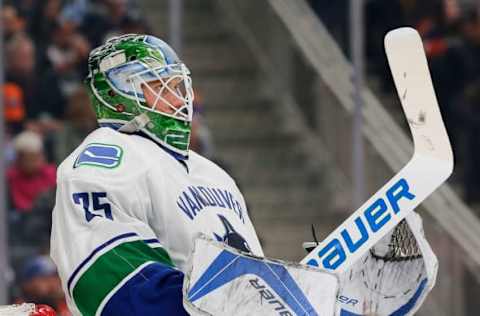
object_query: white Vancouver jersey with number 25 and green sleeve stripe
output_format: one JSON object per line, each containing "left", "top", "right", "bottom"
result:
{"left": 51, "top": 128, "right": 263, "bottom": 315}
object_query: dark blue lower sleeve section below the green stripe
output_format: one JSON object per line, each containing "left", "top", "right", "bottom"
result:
{"left": 101, "top": 263, "right": 188, "bottom": 316}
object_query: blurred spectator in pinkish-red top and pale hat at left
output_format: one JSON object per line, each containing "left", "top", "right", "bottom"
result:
{"left": 7, "top": 131, "right": 56, "bottom": 213}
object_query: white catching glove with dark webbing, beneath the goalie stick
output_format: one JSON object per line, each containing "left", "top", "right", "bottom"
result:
{"left": 304, "top": 212, "right": 438, "bottom": 316}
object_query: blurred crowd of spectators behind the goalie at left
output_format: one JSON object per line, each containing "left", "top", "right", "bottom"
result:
{"left": 0, "top": 0, "right": 212, "bottom": 315}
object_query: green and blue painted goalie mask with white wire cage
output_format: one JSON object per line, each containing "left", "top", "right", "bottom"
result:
{"left": 85, "top": 34, "right": 193, "bottom": 158}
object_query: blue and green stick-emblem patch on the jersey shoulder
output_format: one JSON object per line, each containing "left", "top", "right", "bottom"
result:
{"left": 73, "top": 143, "right": 123, "bottom": 169}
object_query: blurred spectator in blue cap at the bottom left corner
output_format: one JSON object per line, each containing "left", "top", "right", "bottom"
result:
{"left": 17, "top": 255, "right": 71, "bottom": 316}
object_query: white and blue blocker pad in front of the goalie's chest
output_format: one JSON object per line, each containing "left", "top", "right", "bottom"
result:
{"left": 183, "top": 235, "right": 338, "bottom": 316}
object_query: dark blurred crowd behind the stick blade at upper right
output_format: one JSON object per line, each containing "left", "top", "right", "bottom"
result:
{"left": 309, "top": 0, "right": 480, "bottom": 205}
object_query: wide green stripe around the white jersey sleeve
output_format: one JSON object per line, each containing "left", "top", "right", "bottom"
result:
{"left": 73, "top": 240, "right": 173, "bottom": 315}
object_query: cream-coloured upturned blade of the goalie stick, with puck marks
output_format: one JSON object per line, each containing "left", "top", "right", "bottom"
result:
{"left": 385, "top": 27, "right": 453, "bottom": 168}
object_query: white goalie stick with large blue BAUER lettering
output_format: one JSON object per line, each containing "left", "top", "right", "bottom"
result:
{"left": 301, "top": 27, "right": 453, "bottom": 273}
